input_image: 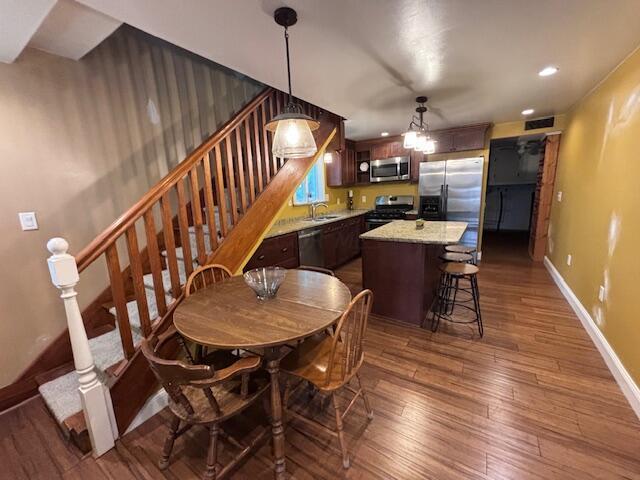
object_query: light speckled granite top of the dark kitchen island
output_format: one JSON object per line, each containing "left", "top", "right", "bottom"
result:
{"left": 360, "top": 220, "right": 467, "bottom": 245}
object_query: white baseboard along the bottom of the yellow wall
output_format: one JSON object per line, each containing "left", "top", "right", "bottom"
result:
{"left": 544, "top": 256, "right": 640, "bottom": 418}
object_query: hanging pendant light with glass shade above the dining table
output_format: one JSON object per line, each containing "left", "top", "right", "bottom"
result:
{"left": 265, "top": 7, "right": 320, "bottom": 158}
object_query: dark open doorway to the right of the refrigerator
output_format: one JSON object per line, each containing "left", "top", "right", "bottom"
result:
{"left": 483, "top": 134, "right": 546, "bottom": 256}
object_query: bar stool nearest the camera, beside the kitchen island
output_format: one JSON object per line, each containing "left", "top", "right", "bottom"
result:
{"left": 431, "top": 262, "right": 484, "bottom": 337}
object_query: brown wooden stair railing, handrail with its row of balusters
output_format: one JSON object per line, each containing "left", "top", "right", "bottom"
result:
{"left": 76, "top": 88, "right": 319, "bottom": 362}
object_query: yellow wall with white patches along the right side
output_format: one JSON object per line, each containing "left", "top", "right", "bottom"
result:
{"left": 547, "top": 50, "right": 640, "bottom": 384}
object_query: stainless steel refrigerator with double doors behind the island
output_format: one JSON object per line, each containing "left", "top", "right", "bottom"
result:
{"left": 418, "top": 157, "right": 484, "bottom": 248}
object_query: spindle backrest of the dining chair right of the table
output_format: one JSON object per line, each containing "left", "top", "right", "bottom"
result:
{"left": 326, "top": 290, "right": 373, "bottom": 383}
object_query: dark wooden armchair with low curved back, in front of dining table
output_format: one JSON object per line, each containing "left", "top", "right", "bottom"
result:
{"left": 141, "top": 332, "right": 270, "bottom": 480}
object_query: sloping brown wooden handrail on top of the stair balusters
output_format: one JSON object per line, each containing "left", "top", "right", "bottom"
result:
{"left": 76, "top": 87, "right": 275, "bottom": 272}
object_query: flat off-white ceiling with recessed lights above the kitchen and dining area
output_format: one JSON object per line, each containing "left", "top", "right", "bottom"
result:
{"left": 18, "top": 0, "right": 640, "bottom": 139}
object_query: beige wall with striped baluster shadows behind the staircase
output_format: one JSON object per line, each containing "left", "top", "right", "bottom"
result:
{"left": 0, "top": 27, "right": 262, "bottom": 387}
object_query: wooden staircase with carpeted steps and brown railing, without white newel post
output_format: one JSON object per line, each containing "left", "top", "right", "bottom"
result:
{"left": 36, "top": 88, "right": 342, "bottom": 450}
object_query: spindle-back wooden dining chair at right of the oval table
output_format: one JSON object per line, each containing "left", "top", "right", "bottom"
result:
{"left": 280, "top": 290, "right": 373, "bottom": 468}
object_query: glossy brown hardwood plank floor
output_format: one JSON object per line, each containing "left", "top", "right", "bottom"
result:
{"left": 0, "top": 242, "right": 640, "bottom": 480}
